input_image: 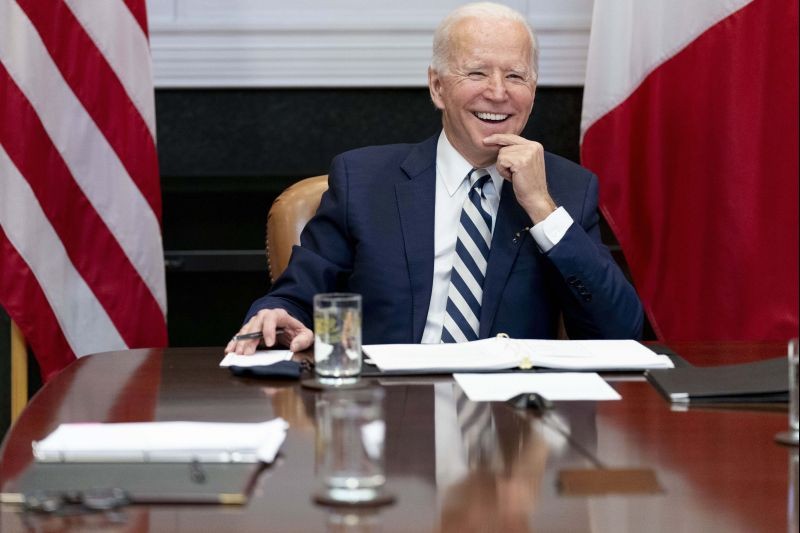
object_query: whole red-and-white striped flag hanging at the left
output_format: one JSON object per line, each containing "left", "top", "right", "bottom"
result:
{"left": 0, "top": 0, "right": 167, "bottom": 379}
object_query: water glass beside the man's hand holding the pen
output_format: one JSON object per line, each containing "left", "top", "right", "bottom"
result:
{"left": 314, "top": 293, "right": 361, "bottom": 385}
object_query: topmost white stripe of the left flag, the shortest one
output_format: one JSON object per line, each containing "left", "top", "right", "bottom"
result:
{"left": 66, "top": 0, "right": 156, "bottom": 142}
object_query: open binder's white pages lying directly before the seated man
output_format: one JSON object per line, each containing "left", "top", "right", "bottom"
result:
{"left": 363, "top": 337, "right": 674, "bottom": 372}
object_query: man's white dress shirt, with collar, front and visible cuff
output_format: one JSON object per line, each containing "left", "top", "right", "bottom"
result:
{"left": 422, "top": 131, "right": 572, "bottom": 344}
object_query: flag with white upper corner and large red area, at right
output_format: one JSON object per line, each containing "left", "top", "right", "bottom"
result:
{"left": 581, "top": 0, "right": 798, "bottom": 340}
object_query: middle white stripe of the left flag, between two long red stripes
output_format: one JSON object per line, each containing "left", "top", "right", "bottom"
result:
{"left": 0, "top": 0, "right": 167, "bottom": 315}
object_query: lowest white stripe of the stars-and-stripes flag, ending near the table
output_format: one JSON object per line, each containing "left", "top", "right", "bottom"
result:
{"left": 0, "top": 145, "right": 127, "bottom": 357}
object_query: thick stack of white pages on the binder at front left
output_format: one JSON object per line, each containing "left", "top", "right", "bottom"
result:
{"left": 33, "top": 418, "right": 289, "bottom": 463}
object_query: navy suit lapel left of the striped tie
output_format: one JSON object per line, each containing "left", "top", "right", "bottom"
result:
{"left": 395, "top": 135, "right": 438, "bottom": 342}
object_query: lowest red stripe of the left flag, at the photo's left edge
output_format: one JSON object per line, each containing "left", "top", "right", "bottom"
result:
{"left": 0, "top": 227, "right": 75, "bottom": 379}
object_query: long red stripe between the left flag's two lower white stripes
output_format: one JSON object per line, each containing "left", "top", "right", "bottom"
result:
{"left": 0, "top": 63, "right": 166, "bottom": 346}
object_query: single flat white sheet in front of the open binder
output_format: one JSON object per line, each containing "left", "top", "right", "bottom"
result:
{"left": 453, "top": 372, "right": 622, "bottom": 402}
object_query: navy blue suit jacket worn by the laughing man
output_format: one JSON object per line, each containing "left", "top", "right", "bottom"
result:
{"left": 247, "top": 135, "right": 643, "bottom": 344}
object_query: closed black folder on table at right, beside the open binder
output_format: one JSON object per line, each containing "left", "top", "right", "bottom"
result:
{"left": 645, "top": 357, "right": 789, "bottom": 404}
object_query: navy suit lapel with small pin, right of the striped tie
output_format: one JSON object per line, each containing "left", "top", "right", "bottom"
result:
{"left": 480, "top": 182, "right": 533, "bottom": 337}
